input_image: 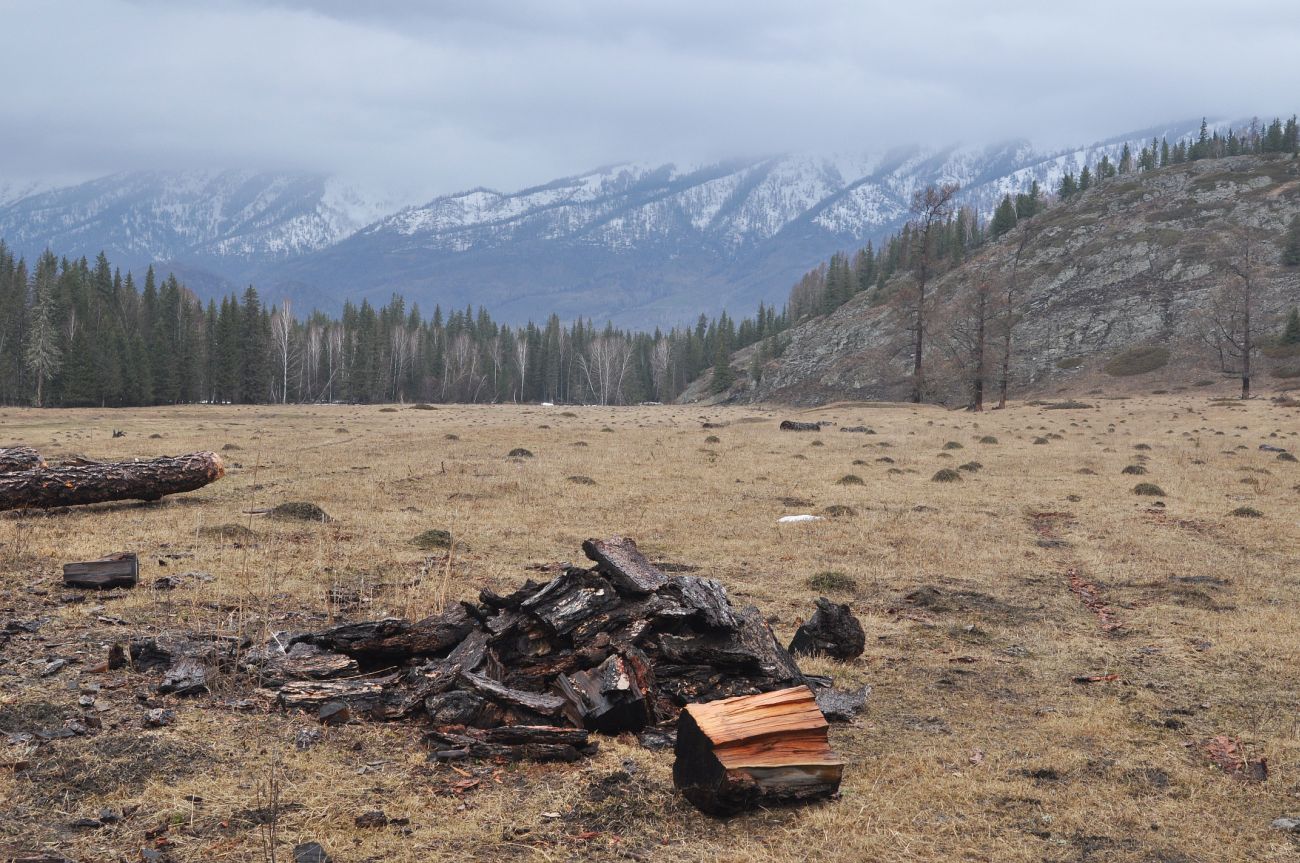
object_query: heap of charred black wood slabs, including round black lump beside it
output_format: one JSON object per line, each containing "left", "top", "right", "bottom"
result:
{"left": 242, "top": 537, "right": 866, "bottom": 760}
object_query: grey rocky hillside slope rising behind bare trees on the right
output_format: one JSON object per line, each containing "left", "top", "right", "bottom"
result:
{"left": 702, "top": 156, "right": 1300, "bottom": 404}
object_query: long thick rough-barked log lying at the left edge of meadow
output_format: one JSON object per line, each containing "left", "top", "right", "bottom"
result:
{"left": 0, "top": 452, "right": 225, "bottom": 511}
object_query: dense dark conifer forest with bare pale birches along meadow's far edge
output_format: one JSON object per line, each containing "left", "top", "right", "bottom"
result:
{"left": 0, "top": 242, "right": 789, "bottom": 407}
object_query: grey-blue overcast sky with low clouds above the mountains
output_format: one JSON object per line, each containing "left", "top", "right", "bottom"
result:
{"left": 0, "top": 0, "right": 1300, "bottom": 194}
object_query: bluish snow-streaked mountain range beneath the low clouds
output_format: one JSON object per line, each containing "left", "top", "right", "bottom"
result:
{"left": 0, "top": 123, "right": 1196, "bottom": 326}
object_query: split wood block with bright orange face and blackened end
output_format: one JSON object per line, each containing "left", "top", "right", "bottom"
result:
{"left": 672, "top": 686, "right": 844, "bottom": 816}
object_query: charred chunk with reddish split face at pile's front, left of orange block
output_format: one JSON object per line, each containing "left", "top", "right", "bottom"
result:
{"left": 555, "top": 646, "right": 654, "bottom": 734}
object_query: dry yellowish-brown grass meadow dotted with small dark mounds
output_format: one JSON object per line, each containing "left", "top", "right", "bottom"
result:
{"left": 0, "top": 395, "right": 1300, "bottom": 863}
